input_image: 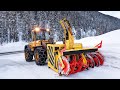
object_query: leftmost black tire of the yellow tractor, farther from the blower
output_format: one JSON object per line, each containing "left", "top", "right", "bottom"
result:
{"left": 24, "top": 45, "right": 33, "bottom": 62}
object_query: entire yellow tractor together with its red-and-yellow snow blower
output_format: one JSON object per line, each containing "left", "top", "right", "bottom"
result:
{"left": 24, "top": 18, "right": 104, "bottom": 76}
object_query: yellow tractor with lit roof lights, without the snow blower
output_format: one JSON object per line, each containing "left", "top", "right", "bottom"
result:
{"left": 24, "top": 26, "right": 53, "bottom": 65}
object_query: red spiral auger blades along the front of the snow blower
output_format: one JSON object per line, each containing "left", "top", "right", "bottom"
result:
{"left": 58, "top": 51, "right": 104, "bottom": 76}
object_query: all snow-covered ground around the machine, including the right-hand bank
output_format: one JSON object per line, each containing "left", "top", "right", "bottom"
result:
{"left": 0, "top": 30, "right": 120, "bottom": 79}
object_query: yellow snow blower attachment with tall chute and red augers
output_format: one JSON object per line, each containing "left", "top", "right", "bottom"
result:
{"left": 47, "top": 19, "right": 104, "bottom": 76}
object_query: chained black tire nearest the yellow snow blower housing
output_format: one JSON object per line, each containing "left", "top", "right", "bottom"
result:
{"left": 34, "top": 47, "right": 47, "bottom": 65}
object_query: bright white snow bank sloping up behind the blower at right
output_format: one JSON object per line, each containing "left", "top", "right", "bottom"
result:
{"left": 75, "top": 30, "right": 120, "bottom": 47}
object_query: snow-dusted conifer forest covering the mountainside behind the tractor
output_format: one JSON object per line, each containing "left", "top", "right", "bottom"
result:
{"left": 0, "top": 11, "right": 120, "bottom": 44}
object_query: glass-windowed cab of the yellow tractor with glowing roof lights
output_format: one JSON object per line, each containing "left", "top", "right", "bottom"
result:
{"left": 32, "top": 27, "right": 50, "bottom": 41}
